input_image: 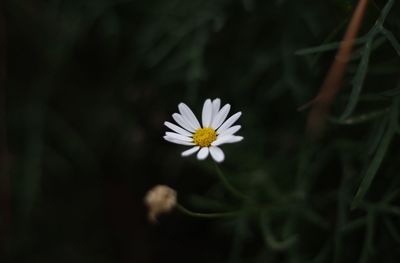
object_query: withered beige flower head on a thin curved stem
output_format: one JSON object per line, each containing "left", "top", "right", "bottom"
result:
{"left": 144, "top": 185, "right": 176, "bottom": 223}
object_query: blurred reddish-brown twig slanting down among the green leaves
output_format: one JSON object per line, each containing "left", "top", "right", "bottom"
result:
{"left": 299, "top": 0, "right": 368, "bottom": 138}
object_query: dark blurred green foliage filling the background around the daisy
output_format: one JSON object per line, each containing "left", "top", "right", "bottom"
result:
{"left": 0, "top": 0, "right": 400, "bottom": 263}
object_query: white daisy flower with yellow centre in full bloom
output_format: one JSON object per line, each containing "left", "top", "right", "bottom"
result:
{"left": 164, "top": 99, "right": 243, "bottom": 162}
